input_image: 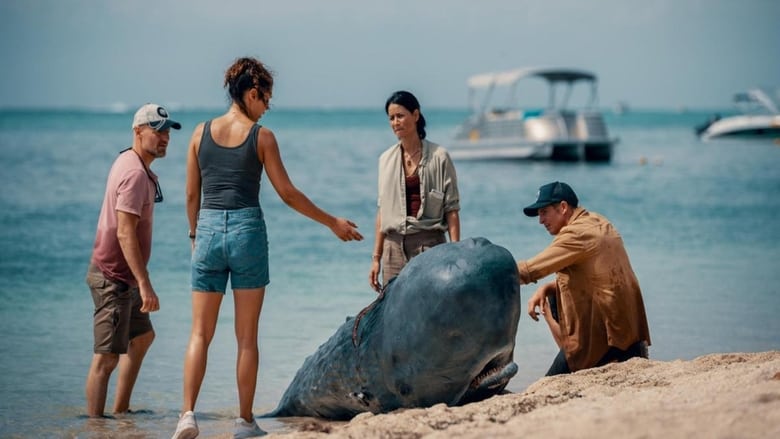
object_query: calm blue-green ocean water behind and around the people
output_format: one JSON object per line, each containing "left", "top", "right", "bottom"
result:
{"left": 0, "top": 109, "right": 780, "bottom": 438}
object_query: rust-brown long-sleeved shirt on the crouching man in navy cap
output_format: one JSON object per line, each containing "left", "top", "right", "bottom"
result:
{"left": 518, "top": 207, "right": 650, "bottom": 371}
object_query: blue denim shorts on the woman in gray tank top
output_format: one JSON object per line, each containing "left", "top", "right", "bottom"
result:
{"left": 192, "top": 207, "right": 270, "bottom": 294}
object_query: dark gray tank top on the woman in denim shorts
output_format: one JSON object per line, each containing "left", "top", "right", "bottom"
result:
{"left": 198, "top": 121, "right": 263, "bottom": 210}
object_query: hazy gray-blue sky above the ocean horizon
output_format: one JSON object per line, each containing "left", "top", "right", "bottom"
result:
{"left": 0, "top": 0, "right": 780, "bottom": 109}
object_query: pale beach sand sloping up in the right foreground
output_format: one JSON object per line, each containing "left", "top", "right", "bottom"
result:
{"left": 270, "top": 351, "right": 780, "bottom": 439}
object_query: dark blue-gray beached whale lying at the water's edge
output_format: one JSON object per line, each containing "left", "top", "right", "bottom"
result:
{"left": 264, "top": 238, "right": 521, "bottom": 419}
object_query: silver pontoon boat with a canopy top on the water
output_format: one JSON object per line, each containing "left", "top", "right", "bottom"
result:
{"left": 447, "top": 68, "right": 617, "bottom": 161}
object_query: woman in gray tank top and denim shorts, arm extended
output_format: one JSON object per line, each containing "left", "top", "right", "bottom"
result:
{"left": 173, "top": 58, "right": 363, "bottom": 439}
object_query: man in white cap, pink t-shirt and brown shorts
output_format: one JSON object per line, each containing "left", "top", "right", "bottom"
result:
{"left": 86, "top": 104, "right": 181, "bottom": 417}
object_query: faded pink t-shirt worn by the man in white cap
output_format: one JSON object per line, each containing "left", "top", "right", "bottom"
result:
{"left": 92, "top": 150, "right": 157, "bottom": 286}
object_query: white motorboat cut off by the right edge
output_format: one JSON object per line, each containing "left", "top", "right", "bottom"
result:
{"left": 696, "top": 88, "right": 780, "bottom": 141}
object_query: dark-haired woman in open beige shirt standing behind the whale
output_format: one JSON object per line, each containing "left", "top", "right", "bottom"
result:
{"left": 368, "top": 91, "right": 460, "bottom": 292}
